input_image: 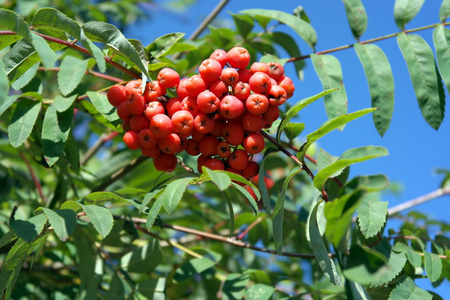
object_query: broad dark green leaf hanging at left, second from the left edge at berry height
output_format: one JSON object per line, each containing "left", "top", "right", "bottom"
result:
{"left": 42, "top": 105, "right": 73, "bottom": 167}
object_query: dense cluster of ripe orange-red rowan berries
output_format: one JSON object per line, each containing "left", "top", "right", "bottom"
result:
{"left": 107, "top": 47, "right": 295, "bottom": 178}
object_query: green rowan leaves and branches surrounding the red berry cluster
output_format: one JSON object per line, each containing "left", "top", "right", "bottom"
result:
{"left": 0, "top": 0, "right": 450, "bottom": 299}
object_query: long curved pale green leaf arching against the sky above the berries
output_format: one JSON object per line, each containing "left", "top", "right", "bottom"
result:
{"left": 240, "top": 8, "right": 317, "bottom": 50}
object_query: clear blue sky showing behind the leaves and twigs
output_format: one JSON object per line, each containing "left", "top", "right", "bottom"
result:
{"left": 125, "top": 0, "right": 450, "bottom": 295}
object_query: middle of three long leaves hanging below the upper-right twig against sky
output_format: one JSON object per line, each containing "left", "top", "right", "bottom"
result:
{"left": 354, "top": 43, "right": 395, "bottom": 136}
